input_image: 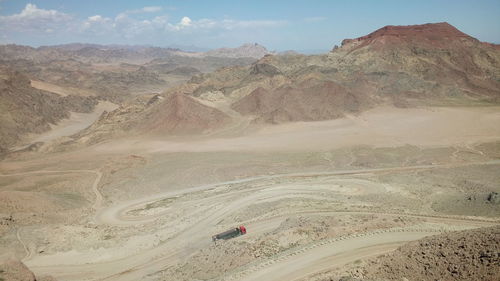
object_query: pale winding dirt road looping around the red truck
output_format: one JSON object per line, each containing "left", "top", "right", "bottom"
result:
{"left": 1, "top": 160, "right": 500, "bottom": 280}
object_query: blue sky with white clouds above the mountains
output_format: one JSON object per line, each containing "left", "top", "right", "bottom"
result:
{"left": 0, "top": 0, "right": 500, "bottom": 52}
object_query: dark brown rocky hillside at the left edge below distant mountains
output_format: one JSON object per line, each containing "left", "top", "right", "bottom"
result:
{"left": 0, "top": 67, "right": 97, "bottom": 152}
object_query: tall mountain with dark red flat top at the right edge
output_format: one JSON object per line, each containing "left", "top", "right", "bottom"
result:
{"left": 334, "top": 23, "right": 500, "bottom": 102}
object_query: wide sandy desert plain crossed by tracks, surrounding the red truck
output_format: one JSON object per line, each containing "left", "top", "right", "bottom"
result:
{"left": 0, "top": 103, "right": 500, "bottom": 280}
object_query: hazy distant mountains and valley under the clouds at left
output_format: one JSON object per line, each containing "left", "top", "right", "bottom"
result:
{"left": 0, "top": 44, "right": 263, "bottom": 103}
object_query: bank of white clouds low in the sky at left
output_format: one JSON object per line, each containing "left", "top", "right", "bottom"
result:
{"left": 0, "top": 3, "right": 288, "bottom": 43}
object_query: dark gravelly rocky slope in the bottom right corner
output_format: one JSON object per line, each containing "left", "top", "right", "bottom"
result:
{"left": 314, "top": 226, "right": 500, "bottom": 281}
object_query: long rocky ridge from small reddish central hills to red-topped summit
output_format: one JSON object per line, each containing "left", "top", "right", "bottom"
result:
{"left": 45, "top": 23, "right": 500, "bottom": 144}
